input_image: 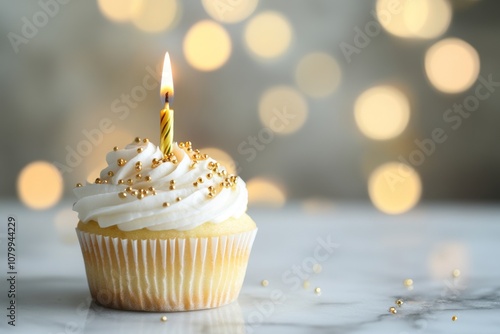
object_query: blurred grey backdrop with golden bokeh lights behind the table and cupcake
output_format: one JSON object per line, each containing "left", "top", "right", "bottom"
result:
{"left": 0, "top": 0, "right": 500, "bottom": 214}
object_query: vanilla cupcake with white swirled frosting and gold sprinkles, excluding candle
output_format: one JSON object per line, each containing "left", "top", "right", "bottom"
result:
{"left": 73, "top": 138, "right": 257, "bottom": 311}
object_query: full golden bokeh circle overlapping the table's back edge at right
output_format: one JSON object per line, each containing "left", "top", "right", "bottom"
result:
{"left": 368, "top": 162, "right": 422, "bottom": 214}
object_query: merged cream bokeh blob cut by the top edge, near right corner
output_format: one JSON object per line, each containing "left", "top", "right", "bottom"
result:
{"left": 376, "top": 0, "right": 452, "bottom": 39}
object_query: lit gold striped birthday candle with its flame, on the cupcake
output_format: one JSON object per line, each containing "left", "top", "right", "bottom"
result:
{"left": 160, "top": 52, "right": 174, "bottom": 154}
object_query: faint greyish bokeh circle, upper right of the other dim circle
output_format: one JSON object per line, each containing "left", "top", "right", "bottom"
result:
{"left": 295, "top": 52, "right": 341, "bottom": 97}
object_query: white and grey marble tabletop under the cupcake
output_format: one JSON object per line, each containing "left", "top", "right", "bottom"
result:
{"left": 0, "top": 202, "right": 500, "bottom": 334}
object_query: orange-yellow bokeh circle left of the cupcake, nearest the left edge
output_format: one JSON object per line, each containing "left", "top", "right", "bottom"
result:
{"left": 17, "top": 161, "right": 63, "bottom": 209}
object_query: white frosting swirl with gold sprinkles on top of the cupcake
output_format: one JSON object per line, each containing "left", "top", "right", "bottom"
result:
{"left": 73, "top": 140, "right": 248, "bottom": 231}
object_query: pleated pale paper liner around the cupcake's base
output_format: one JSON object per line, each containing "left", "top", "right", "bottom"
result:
{"left": 76, "top": 229, "right": 257, "bottom": 311}
